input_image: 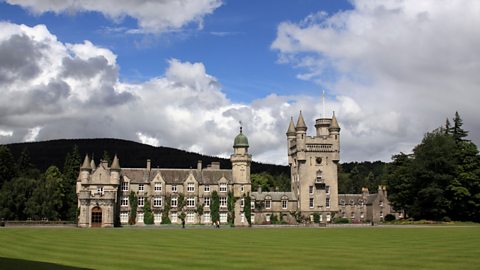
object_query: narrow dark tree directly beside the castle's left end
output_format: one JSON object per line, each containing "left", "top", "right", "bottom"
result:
{"left": 62, "top": 145, "right": 81, "bottom": 221}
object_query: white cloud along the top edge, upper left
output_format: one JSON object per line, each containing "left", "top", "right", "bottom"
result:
{"left": 6, "top": 0, "right": 222, "bottom": 33}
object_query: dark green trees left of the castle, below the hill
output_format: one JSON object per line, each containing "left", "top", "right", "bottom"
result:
{"left": 0, "top": 146, "right": 81, "bottom": 221}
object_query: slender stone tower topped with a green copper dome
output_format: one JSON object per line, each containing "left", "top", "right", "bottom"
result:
{"left": 230, "top": 127, "right": 252, "bottom": 226}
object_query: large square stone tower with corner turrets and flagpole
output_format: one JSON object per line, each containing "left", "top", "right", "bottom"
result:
{"left": 287, "top": 112, "right": 340, "bottom": 222}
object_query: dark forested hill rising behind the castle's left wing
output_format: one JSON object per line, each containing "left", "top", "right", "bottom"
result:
{"left": 6, "top": 139, "right": 290, "bottom": 175}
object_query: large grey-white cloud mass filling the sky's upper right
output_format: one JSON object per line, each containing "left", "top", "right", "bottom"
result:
{"left": 271, "top": 0, "right": 480, "bottom": 160}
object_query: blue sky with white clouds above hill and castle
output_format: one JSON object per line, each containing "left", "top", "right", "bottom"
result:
{"left": 0, "top": 0, "right": 480, "bottom": 164}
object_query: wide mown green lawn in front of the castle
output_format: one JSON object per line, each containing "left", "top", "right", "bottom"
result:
{"left": 0, "top": 226, "right": 480, "bottom": 270}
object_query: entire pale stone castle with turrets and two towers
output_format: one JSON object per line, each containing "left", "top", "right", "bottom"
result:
{"left": 76, "top": 112, "right": 393, "bottom": 227}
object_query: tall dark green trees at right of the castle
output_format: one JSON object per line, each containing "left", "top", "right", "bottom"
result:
{"left": 387, "top": 112, "right": 480, "bottom": 222}
